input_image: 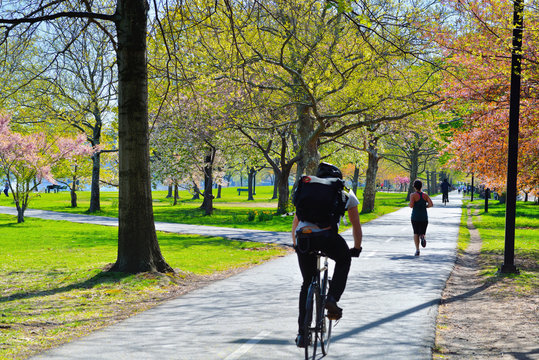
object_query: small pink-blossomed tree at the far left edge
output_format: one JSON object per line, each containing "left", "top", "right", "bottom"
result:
{"left": 0, "top": 115, "right": 93, "bottom": 223}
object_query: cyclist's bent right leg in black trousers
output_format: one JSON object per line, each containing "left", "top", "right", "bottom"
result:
{"left": 322, "top": 234, "right": 351, "bottom": 302}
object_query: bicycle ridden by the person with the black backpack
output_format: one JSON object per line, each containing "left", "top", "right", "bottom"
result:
{"left": 303, "top": 251, "right": 333, "bottom": 360}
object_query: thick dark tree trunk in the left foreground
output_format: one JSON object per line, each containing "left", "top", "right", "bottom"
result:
{"left": 111, "top": 0, "right": 174, "bottom": 273}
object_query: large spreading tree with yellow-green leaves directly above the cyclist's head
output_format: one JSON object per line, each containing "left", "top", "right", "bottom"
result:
{"left": 177, "top": 0, "right": 442, "bottom": 179}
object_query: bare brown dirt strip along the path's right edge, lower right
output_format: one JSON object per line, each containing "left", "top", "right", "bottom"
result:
{"left": 433, "top": 207, "right": 539, "bottom": 360}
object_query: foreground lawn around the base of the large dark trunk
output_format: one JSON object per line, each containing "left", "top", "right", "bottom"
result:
{"left": 0, "top": 215, "right": 286, "bottom": 359}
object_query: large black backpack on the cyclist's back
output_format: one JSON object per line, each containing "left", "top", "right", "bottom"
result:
{"left": 292, "top": 176, "right": 346, "bottom": 228}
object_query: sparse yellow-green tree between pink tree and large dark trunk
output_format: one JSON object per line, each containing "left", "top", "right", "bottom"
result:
{"left": 3, "top": 23, "right": 117, "bottom": 212}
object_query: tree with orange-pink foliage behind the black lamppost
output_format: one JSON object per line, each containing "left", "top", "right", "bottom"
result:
{"left": 429, "top": 1, "right": 539, "bottom": 191}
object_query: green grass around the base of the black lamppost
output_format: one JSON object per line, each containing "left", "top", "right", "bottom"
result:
{"left": 473, "top": 201, "right": 539, "bottom": 293}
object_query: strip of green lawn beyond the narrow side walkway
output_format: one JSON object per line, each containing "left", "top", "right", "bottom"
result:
{"left": 0, "top": 186, "right": 408, "bottom": 231}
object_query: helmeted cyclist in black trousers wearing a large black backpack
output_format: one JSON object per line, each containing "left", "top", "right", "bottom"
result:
{"left": 292, "top": 162, "right": 362, "bottom": 347}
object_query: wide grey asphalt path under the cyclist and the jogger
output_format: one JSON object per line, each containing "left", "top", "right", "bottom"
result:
{"left": 0, "top": 193, "right": 461, "bottom": 360}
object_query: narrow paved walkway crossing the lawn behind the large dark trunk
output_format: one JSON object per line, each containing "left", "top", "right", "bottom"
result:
{"left": 0, "top": 206, "right": 292, "bottom": 245}
